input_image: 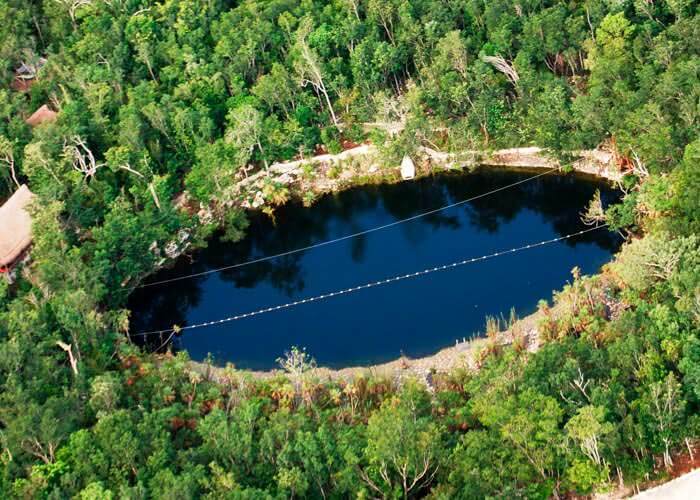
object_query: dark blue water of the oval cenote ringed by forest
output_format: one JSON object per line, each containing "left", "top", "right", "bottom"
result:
{"left": 129, "top": 168, "right": 620, "bottom": 369}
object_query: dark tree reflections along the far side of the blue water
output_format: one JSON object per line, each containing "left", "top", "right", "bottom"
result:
{"left": 128, "top": 169, "right": 620, "bottom": 340}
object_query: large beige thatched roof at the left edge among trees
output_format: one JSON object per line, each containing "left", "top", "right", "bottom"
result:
{"left": 0, "top": 184, "right": 34, "bottom": 266}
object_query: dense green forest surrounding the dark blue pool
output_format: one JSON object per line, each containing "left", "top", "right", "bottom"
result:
{"left": 0, "top": 0, "right": 700, "bottom": 499}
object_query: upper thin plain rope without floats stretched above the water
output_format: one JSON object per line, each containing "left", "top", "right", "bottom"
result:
{"left": 134, "top": 168, "right": 557, "bottom": 291}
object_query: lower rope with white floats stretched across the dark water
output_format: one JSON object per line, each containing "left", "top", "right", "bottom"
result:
{"left": 130, "top": 224, "right": 607, "bottom": 337}
